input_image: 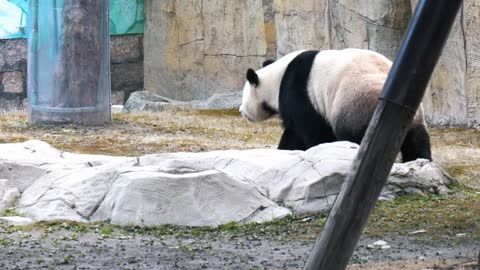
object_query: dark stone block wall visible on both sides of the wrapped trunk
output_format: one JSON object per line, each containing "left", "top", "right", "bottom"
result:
{"left": 0, "top": 34, "right": 143, "bottom": 111}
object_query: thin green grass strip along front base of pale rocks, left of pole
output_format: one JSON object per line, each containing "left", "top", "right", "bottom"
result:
{"left": 3, "top": 215, "right": 325, "bottom": 241}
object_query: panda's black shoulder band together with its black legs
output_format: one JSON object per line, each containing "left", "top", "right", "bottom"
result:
{"left": 278, "top": 51, "right": 432, "bottom": 162}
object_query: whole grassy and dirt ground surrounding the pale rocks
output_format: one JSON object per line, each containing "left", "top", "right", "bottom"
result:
{"left": 0, "top": 111, "right": 480, "bottom": 269}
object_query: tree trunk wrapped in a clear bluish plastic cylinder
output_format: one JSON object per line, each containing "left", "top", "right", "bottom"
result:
{"left": 27, "top": 0, "right": 111, "bottom": 125}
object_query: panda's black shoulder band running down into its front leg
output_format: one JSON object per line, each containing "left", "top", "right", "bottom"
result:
{"left": 279, "top": 51, "right": 336, "bottom": 150}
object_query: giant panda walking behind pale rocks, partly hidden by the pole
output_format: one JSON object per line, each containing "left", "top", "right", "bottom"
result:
{"left": 240, "top": 49, "right": 432, "bottom": 162}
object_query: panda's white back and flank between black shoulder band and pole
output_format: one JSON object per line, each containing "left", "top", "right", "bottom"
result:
{"left": 307, "top": 49, "right": 392, "bottom": 133}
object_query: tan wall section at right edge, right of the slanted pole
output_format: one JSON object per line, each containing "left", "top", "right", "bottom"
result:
{"left": 412, "top": 0, "right": 480, "bottom": 126}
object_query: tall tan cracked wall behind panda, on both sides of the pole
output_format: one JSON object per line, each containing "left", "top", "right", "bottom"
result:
{"left": 144, "top": 0, "right": 480, "bottom": 126}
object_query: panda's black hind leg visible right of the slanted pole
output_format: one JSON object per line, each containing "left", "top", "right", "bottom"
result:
{"left": 401, "top": 123, "right": 432, "bottom": 162}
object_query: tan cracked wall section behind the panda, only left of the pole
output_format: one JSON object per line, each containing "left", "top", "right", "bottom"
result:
{"left": 144, "top": 0, "right": 411, "bottom": 100}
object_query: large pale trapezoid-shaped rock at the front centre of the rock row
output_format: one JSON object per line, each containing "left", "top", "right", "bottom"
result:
{"left": 92, "top": 170, "right": 291, "bottom": 226}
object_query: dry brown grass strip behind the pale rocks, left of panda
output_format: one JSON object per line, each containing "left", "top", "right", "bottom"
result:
{"left": 0, "top": 110, "right": 281, "bottom": 156}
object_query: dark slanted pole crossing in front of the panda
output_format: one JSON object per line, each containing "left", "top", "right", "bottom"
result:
{"left": 305, "top": 0, "right": 462, "bottom": 270}
